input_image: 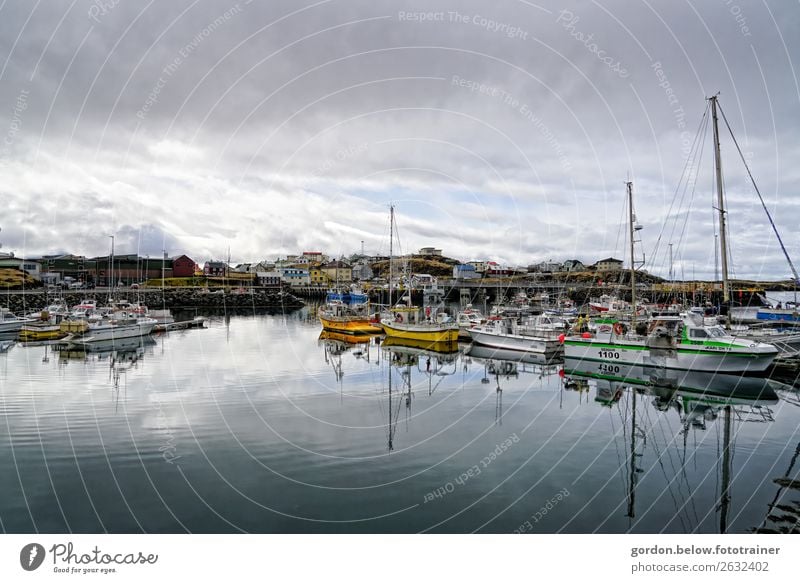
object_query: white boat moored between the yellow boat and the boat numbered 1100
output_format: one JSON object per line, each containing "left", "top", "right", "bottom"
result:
{"left": 468, "top": 315, "right": 569, "bottom": 354}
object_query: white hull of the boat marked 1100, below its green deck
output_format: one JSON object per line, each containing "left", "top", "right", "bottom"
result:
{"left": 564, "top": 338, "right": 777, "bottom": 373}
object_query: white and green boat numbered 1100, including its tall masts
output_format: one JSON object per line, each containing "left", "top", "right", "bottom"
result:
{"left": 564, "top": 110, "right": 778, "bottom": 373}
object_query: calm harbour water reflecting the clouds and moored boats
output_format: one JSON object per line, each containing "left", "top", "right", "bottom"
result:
{"left": 0, "top": 310, "right": 800, "bottom": 533}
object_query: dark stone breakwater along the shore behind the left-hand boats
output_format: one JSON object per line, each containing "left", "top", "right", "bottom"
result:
{"left": 0, "top": 288, "right": 305, "bottom": 314}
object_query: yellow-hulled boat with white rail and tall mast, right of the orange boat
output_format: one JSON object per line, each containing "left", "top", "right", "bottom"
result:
{"left": 381, "top": 206, "right": 459, "bottom": 343}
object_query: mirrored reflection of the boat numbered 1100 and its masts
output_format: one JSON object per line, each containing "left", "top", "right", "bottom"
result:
{"left": 564, "top": 358, "right": 791, "bottom": 533}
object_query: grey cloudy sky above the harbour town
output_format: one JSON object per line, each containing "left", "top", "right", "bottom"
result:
{"left": 0, "top": 0, "right": 800, "bottom": 278}
